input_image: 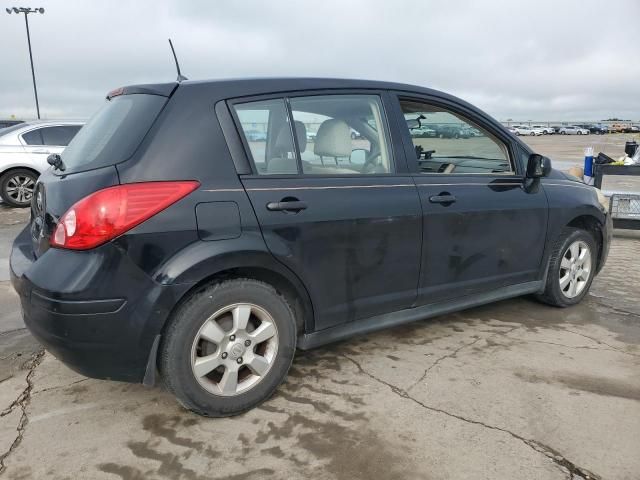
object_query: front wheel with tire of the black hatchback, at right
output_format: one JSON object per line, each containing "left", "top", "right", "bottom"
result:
{"left": 537, "top": 228, "right": 598, "bottom": 307}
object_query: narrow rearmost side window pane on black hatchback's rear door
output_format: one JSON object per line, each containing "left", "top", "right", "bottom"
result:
{"left": 233, "top": 98, "right": 298, "bottom": 175}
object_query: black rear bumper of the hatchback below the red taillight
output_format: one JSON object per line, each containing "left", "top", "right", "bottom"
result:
{"left": 10, "top": 228, "right": 190, "bottom": 382}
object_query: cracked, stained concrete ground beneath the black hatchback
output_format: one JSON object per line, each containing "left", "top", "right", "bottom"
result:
{"left": 0, "top": 204, "right": 640, "bottom": 480}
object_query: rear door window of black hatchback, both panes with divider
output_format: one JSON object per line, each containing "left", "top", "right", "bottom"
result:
{"left": 233, "top": 95, "right": 393, "bottom": 175}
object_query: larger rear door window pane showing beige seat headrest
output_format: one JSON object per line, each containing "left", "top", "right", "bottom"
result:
{"left": 290, "top": 95, "right": 393, "bottom": 175}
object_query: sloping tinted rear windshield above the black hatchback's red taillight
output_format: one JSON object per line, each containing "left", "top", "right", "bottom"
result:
{"left": 61, "top": 94, "right": 167, "bottom": 173}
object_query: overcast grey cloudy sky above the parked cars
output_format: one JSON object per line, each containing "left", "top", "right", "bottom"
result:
{"left": 0, "top": 0, "right": 640, "bottom": 120}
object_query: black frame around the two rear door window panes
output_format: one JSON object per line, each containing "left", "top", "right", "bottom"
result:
{"left": 226, "top": 88, "right": 402, "bottom": 179}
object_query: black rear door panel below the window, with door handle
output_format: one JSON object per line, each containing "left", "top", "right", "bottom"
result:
{"left": 243, "top": 176, "right": 422, "bottom": 329}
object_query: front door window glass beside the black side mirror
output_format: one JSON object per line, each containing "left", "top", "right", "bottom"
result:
{"left": 400, "top": 100, "right": 514, "bottom": 175}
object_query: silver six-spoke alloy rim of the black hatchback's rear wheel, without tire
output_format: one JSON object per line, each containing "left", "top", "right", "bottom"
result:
{"left": 191, "top": 303, "right": 278, "bottom": 396}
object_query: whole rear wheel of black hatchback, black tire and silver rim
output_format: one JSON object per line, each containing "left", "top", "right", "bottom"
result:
{"left": 159, "top": 279, "right": 296, "bottom": 417}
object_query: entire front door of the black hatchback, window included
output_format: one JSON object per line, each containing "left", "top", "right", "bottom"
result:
{"left": 392, "top": 92, "right": 548, "bottom": 305}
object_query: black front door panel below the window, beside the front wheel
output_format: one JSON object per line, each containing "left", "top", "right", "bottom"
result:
{"left": 415, "top": 176, "right": 547, "bottom": 304}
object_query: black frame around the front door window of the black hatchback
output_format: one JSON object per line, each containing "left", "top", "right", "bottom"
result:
{"left": 392, "top": 91, "right": 523, "bottom": 179}
